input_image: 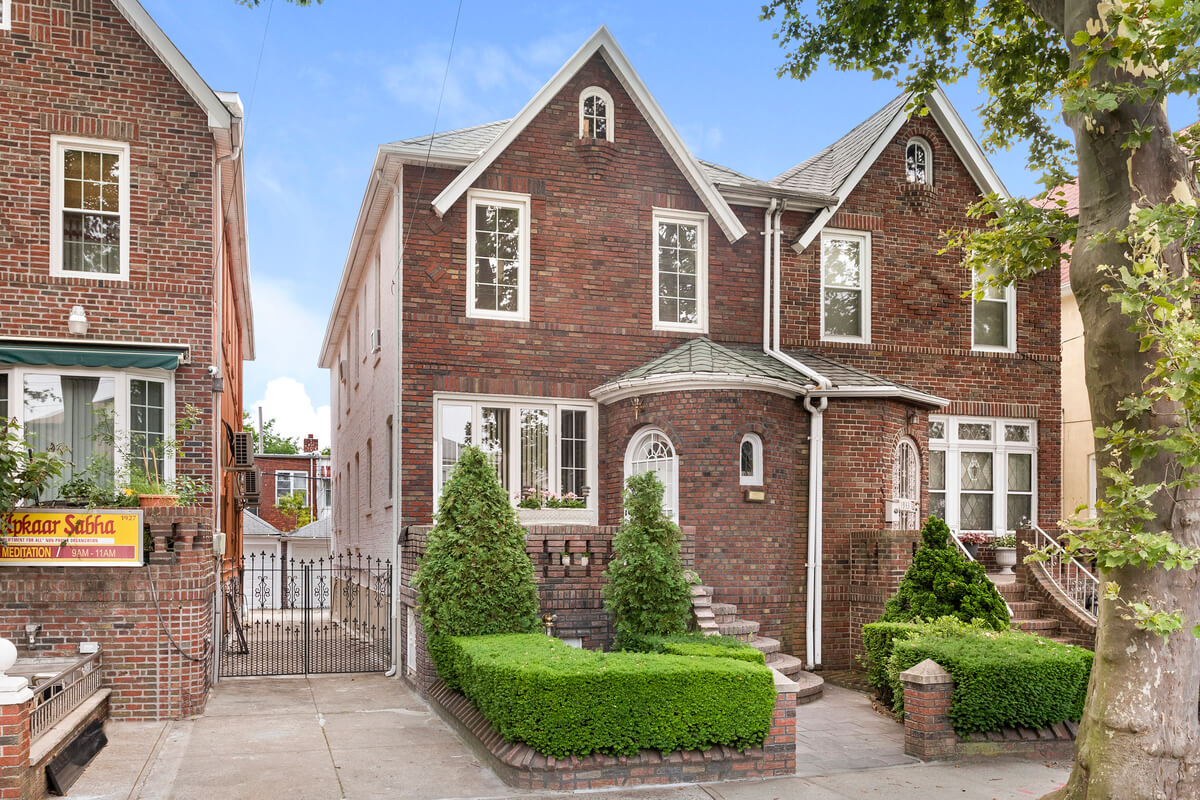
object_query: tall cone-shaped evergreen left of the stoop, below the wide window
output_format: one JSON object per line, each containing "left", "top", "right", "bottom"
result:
{"left": 413, "top": 447, "right": 538, "bottom": 674}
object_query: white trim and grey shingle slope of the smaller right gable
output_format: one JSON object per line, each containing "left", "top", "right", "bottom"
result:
{"left": 772, "top": 88, "right": 1009, "bottom": 252}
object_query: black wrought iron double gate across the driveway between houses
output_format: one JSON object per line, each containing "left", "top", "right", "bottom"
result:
{"left": 221, "top": 553, "right": 392, "bottom": 676}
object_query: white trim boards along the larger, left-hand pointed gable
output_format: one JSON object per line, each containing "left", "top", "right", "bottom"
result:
{"left": 433, "top": 25, "right": 746, "bottom": 241}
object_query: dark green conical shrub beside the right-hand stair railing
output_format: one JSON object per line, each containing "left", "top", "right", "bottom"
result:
{"left": 880, "top": 517, "right": 1008, "bottom": 631}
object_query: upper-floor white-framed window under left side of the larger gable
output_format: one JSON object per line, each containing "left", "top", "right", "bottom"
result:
{"left": 467, "top": 190, "right": 529, "bottom": 320}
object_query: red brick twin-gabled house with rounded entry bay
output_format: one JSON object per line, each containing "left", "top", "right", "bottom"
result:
{"left": 320, "top": 28, "right": 1061, "bottom": 667}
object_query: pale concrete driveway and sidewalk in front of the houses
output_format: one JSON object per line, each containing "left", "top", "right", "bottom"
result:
{"left": 68, "top": 675, "right": 1068, "bottom": 800}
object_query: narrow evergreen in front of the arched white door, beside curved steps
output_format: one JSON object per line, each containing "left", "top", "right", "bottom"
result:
{"left": 604, "top": 473, "right": 691, "bottom": 646}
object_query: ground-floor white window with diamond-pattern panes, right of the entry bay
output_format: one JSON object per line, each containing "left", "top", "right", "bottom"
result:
{"left": 929, "top": 416, "right": 1038, "bottom": 534}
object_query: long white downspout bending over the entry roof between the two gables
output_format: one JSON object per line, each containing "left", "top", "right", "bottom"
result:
{"left": 763, "top": 200, "right": 833, "bottom": 669}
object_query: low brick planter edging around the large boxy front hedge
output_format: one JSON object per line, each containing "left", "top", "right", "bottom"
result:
{"left": 426, "top": 680, "right": 796, "bottom": 792}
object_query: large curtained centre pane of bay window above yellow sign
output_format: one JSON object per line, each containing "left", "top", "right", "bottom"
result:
{"left": 23, "top": 374, "right": 116, "bottom": 499}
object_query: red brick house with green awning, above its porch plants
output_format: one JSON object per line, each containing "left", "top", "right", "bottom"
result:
{"left": 0, "top": 0, "right": 254, "bottom": 568}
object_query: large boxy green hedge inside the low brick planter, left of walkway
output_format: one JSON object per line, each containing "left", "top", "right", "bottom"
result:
{"left": 437, "top": 633, "right": 775, "bottom": 758}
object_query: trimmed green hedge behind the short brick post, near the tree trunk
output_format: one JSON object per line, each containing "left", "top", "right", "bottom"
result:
{"left": 863, "top": 618, "right": 1092, "bottom": 735}
